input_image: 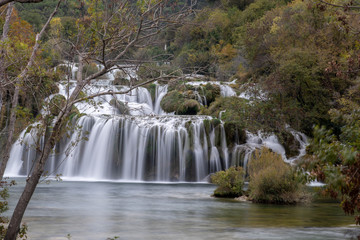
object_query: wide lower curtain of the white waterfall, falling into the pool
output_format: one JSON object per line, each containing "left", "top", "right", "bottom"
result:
{"left": 7, "top": 116, "right": 227, "bottom": 181}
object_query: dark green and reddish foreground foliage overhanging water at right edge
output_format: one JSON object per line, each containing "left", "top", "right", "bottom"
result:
{"left": 304, "top": 92, "right": 360, "bottom": 224}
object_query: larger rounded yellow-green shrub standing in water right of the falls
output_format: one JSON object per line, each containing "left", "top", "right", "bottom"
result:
{"left": 249, "top": 148, "right": 308, "bottom": 204}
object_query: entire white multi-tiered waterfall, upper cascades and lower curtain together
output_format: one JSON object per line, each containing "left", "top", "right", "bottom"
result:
{"left": 5, "top": 65, "right": 307, "bottom": 181}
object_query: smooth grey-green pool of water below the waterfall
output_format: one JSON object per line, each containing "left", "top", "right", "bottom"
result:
{"left": 9, "top": 179, "right": 360, "bottom": 240}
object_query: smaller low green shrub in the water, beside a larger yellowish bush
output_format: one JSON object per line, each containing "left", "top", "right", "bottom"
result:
{"left": 211, "top": 167, "right": 244, "bottom": 198}
